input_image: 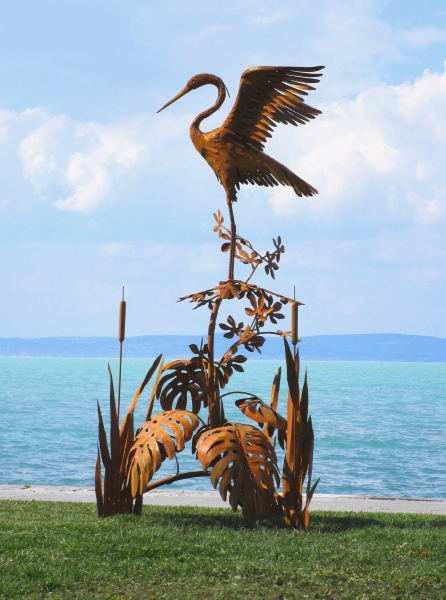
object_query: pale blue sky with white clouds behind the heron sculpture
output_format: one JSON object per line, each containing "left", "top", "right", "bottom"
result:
{"left": 0, "top": 0, "right": 446, "bottom": 337}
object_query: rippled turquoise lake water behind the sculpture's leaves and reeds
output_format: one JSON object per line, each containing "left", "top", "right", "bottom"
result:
{"left": 0, "top": 358, "right": 446, "bottom": 498}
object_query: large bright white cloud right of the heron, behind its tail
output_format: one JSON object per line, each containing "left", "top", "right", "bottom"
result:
{"left": 269, "top": 63, "right": 446, "bottom": 224}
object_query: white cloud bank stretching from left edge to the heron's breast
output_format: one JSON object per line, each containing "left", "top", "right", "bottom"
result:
{"left": 0, "top": 108, "right": 193, "bottom": 214}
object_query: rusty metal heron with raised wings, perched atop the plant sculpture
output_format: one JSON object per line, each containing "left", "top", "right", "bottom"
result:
{"left": 158, "top": 67, "right": 324, "bottom": 280}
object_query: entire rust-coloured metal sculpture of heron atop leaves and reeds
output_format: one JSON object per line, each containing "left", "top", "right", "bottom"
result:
{"left": 96, "top": 67, "right": 322, "bottom": 529}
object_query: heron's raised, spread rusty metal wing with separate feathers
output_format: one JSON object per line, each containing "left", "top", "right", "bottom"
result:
{"left": 220, "top": 67, "right": 324, "bottom": 150}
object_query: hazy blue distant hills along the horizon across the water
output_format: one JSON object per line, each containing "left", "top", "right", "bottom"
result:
{"left": 0, "top": 333, "right": 446, "bottom": 362}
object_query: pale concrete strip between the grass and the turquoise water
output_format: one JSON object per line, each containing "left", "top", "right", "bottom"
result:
{"left": 0, "top": 485, "right": 446, "bottom": 515}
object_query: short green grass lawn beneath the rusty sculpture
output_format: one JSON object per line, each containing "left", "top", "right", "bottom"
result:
{"left": 0, "top": 501, "right": 446, "bottom": 600}
